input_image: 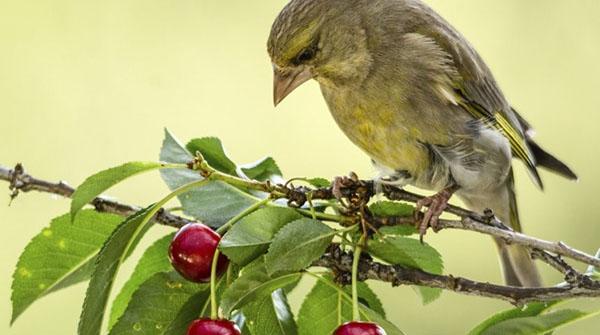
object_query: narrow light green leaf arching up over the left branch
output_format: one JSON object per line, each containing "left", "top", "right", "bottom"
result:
{"left": 71, "top": 162, "right": 165, "bottom": 220}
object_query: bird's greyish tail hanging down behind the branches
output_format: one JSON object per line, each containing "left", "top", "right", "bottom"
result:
{"left": 461, "top": 171, "right": 542, "bottom": 287}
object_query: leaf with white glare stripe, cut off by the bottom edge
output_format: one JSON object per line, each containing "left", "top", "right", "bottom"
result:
{"left": 242, "top": 289, "right": 298, "bottom": 335}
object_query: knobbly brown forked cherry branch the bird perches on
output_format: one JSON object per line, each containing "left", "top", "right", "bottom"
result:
{"left": 0, "top": 164, "right": 600, "bottom": 305}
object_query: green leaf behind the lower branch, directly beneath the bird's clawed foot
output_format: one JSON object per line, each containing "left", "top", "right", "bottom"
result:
{"left": 369, "top": 236, "right": 444, "bottom": 304}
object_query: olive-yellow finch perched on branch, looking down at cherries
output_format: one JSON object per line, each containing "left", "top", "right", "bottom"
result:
{"left": 267, "top": 0, "right": 577, "bottom": 287}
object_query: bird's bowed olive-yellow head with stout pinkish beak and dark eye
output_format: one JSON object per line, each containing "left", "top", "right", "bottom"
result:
{"left": 268, "top": 0, "right": 371, "bottom": 105}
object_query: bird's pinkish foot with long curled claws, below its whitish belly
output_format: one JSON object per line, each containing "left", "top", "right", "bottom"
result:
{"left": 415, "top": 185, "right": 460, "bottom": 242}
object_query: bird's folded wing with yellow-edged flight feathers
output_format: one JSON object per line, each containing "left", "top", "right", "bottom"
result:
{"left": 416, "top": 24, "right": 543, "bottom": 188}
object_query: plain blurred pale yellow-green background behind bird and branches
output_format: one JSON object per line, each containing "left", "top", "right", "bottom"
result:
{"left": 0, "top": 0, "right": 600, "bottom": 335}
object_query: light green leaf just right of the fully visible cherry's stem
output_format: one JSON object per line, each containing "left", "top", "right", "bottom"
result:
{"left": 219, "top": 207, "right": 302, "bottom": 265}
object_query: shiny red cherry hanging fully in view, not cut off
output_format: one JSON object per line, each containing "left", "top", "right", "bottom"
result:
{"left": 169, "top": 223, "right": 229, "bottom": 283}
